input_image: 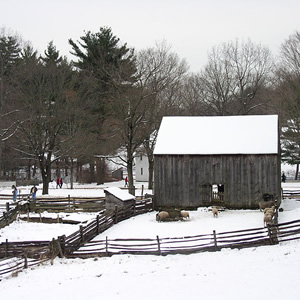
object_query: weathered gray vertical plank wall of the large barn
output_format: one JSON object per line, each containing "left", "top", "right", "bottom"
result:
{"left": 154, "top": 154, "right": 280, "bottom": 208}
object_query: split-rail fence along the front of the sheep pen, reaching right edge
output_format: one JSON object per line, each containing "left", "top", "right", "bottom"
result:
{"left": 68, "top": 220, "right": 300, "bottom": 258}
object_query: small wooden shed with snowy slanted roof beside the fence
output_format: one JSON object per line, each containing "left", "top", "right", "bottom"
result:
{"left": 104, "top": 187, "right": 135, "bottom": 210}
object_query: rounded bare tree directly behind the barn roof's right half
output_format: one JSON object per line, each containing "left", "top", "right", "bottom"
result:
{"left": 201, "top": 40, "right": 273, "bottom": 115}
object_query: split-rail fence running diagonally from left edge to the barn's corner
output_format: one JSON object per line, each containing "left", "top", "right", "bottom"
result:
{"left": 0, "top": 199, "right": 153, "bottom": 280}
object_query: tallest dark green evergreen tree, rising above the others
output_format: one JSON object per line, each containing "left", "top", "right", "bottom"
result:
{"left": 69, "top": 27, "right": 135, "bottom": 184}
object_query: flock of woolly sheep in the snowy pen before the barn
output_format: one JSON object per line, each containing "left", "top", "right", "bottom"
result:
{"left": 156, "top": 201, "right": 275, "bottom": 226}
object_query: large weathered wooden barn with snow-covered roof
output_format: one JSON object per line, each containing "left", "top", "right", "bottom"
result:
{"left": 154, "top": 115, "right": 281, "bottom": 209}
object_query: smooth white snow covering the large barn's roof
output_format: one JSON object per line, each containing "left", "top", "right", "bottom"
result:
{"left": 154, "top": 115, "right": 278, "bottom": 155}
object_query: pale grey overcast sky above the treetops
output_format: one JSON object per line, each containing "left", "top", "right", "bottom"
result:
{"left": 0, "top": 0, "right": 300, "bottom": 72}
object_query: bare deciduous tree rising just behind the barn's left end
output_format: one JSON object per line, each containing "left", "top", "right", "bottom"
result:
{"left": 137, "top": 41, "right": 188, "bottom": 189}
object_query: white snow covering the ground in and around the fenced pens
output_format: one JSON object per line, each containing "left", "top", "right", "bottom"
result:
{"left": 0, "top": 182, "right": 300, "bottom": 300}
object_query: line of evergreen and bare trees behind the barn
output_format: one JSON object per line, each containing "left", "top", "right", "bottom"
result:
{"left": 0, "top": 27, "right": 300, "bottom": 194}
